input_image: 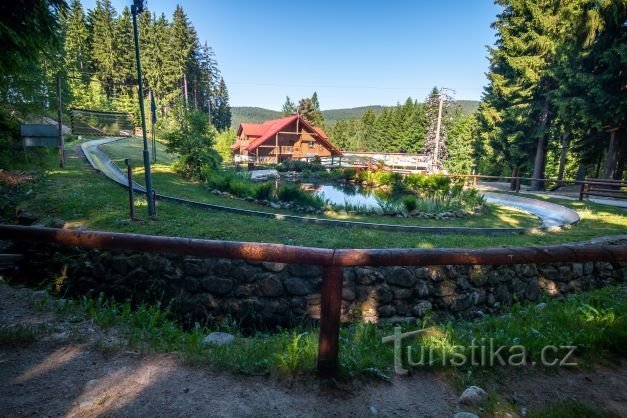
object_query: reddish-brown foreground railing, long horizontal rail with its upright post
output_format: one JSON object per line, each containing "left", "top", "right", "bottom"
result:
{"left": 0, "top": 225, "right": 627, "bottom": 377}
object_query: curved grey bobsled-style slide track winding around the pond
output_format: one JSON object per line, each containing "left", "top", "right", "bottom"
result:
{"left": 81, "top": 138, "right": 579, "bottom": 235}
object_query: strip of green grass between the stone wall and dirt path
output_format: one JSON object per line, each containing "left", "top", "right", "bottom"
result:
{"left": 43, "top": 287, "right": 627, "bottom": 385}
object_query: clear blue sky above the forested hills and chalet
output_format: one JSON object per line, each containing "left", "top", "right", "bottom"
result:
{"left": 83, "top": 0, "right": 499, "bottom": 110}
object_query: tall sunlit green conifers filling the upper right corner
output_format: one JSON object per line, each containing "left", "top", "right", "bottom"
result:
{"left": 474, "top": 0, "right": 627, "bottom": 179}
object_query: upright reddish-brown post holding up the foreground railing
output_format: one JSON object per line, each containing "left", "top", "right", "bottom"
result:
{"left": 318, "top": 266, "right": 343, "bottom": 378}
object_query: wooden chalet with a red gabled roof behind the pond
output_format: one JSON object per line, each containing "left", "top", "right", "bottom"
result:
{"left": 231, "top": 115, "right": 342, "bottom": 164}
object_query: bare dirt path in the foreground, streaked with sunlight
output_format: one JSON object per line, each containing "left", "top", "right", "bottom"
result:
{"left": 0, "top": 281, "right": 627, "bottom": 418}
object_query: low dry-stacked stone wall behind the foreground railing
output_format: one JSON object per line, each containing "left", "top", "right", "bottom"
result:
{"left": 17, "top": 246, "right": 627, "bottom": 326}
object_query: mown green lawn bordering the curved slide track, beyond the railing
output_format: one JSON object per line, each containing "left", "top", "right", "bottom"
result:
{"left": 6, "top": 140, "right": 627, "bottom": 248}
